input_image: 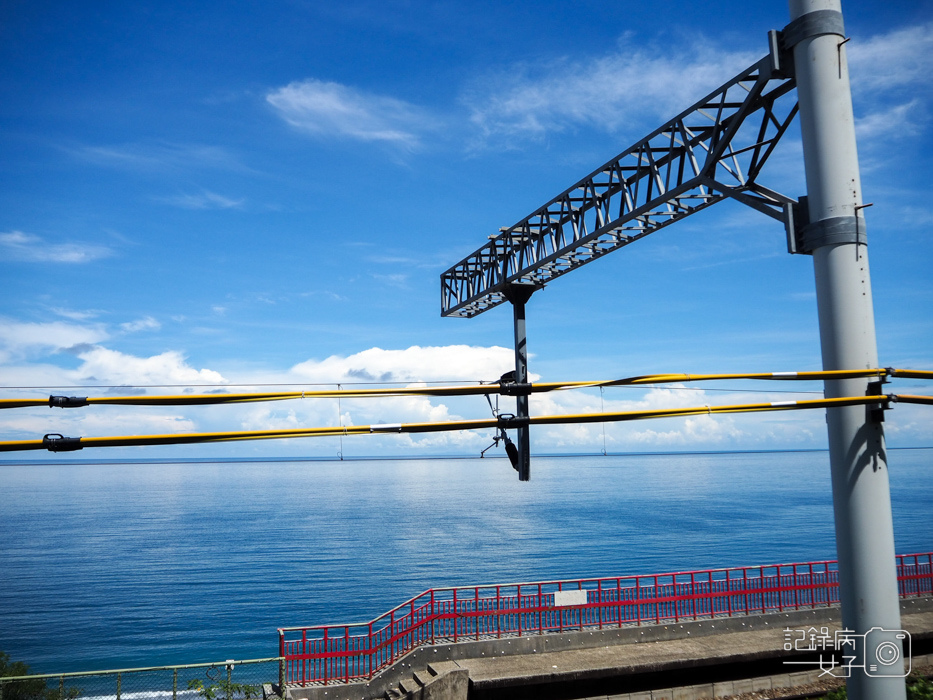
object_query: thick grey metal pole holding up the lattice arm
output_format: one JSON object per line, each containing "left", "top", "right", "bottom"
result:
{"left": 784, "top": 0, "right": 906, "bottom": 700}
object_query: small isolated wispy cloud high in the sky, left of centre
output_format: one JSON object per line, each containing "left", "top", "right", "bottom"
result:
{"left": 266, "top": 78, "right": 432, "bottom": 148}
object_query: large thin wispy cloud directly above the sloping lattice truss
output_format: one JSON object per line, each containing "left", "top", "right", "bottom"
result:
{"left": 463, "top": 36, "right": 761, "bottom": 145}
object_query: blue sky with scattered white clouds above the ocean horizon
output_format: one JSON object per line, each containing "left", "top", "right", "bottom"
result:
{"left": 0, "top": 0, "right": 933, "bottom": 458}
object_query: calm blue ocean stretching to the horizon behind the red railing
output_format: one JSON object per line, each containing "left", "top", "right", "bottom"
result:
{"left": 0, "top": 449, "right": 933, "bottom": 673}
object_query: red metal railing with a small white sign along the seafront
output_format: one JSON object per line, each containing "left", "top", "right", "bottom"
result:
{"left": 279, "top": 552, "right": 933, "bottom": 685}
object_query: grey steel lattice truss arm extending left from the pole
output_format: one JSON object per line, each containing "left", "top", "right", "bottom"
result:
{"left": 441, "top": 56, "right": 797, "bottom": 317}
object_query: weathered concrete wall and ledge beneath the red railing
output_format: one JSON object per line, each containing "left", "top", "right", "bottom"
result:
{"left": 288, "top": 598, "right": 933, "bottom": 700}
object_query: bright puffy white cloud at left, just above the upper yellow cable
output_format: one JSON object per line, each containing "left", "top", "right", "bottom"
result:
{"left": 68, "top": 345, "right": 226, "bottom": 386}
